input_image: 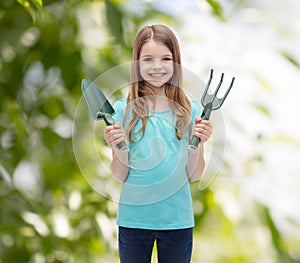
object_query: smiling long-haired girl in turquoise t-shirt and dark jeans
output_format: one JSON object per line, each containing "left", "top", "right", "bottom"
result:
{"left": 104, "top": 25, "right": 212, "bottom": 263}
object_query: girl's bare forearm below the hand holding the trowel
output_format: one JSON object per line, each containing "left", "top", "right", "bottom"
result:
{"left": 110, "top": 150, "right": 129, "bottom": 182}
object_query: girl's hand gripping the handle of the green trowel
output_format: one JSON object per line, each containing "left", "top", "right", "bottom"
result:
{"left": 104, "top": 123, "right": 126, "bottom": 149}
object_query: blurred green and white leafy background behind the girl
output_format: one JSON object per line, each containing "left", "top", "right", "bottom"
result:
{"left": 0, "top": 0, "right": 300, "bottom": 263}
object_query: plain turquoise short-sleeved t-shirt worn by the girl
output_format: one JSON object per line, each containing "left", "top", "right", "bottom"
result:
{"left": 113, "top": 99, "right": 202, "bottom": 230}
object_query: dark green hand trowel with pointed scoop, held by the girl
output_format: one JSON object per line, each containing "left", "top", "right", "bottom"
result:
{"left": 81, "top": 79, "right": 128, "bottom": 151}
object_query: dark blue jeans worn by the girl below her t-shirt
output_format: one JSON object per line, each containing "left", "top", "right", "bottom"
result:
{"left": 119, "top": 226, "right": 193, "bottom": 263}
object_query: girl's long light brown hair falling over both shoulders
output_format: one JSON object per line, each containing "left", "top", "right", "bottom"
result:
{"left": 125, "top": 25, "right": 191, "bottom": 142}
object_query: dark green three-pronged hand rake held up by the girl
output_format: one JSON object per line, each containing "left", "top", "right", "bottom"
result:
{"left": 188, "top": 69, "right": 235, "bottom": 151}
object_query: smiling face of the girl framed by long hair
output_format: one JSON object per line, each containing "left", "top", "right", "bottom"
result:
{"left": 139, "top": 40, "right": 174, "bottom": 91}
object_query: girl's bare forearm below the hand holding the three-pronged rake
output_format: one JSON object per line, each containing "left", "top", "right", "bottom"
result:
{"left": 186, "top": 144, "right": 205, "bottom": 182}
